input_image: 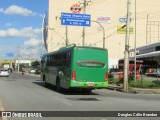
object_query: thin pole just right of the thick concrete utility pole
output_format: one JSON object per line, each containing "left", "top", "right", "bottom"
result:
{"left": 134, "top": 0, "right": 137, "bottom": 81}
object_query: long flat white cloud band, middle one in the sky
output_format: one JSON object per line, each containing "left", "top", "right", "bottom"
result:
{"left": 0, "top": 27, "right": 41, "bottom": 38}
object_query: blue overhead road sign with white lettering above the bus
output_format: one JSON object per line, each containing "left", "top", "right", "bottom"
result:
{"left": 61, "top": 13, "right": 91, "bottom": 26}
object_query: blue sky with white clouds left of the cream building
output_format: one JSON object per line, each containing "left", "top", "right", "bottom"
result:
{"left": 0, "top": 0, "right": 48, "bottom": 59}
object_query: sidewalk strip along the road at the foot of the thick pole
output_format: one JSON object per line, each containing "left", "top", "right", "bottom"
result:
{"left": 108, "top": 84, "right": 160, "bottom": 94}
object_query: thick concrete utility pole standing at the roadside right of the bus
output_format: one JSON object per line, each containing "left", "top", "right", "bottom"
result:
{"left": 123, "top": 0, "right": 131, "bottom": 93}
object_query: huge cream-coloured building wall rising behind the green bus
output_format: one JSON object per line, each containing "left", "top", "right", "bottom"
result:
{"left": 47, "top": 0, "right": 160, "bottom": 66}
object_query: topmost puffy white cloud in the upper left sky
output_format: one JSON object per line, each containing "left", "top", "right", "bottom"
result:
{"left": 0, "top": 5, "right": 37, "bottom": 16}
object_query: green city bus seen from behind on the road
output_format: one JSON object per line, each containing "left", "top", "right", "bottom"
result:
{"left": 41, "top": 46, "right": 108, "bottom": 92}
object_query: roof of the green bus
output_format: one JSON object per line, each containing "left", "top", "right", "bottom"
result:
{"left": 43, "top": 46, "right": 107, "bottom": 56}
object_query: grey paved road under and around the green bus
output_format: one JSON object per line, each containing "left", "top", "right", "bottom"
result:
{"left": 0, "top": 73, "right": 160, "bottom": 120}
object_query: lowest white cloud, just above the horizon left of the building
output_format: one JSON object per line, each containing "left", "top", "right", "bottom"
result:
{"left": 0, "top": 38, "right": 46, "bottom": 59}
